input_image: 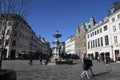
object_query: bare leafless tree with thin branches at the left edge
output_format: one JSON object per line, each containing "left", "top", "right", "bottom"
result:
{"left": 0, "top": 0, "right": 31, "bottom": 70}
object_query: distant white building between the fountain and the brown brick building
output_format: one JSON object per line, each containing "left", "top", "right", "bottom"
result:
{"left": 65, "top": 35, "right": 75, "bottom": 54}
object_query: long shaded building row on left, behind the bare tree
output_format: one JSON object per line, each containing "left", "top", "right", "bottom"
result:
{"left": 0, "top": 14, "right": 50, "bottom": 59}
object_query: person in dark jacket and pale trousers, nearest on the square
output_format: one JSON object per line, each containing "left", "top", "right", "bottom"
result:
{"left": 80, "top": 56, "right": 90, "bottom": 80}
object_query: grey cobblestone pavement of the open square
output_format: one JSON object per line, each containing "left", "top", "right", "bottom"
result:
{"left": 2, "top": 60, "right": 120, "bottom": 80}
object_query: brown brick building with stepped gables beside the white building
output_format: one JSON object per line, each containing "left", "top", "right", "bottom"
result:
{"left": 75, "top": 22, "right": 88, "bottom": 58}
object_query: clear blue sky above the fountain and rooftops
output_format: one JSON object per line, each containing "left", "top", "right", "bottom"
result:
{"left": 27, "top": 0, "right": 120, "bottom": 45}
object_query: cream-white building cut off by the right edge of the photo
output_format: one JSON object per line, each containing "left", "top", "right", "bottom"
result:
{"left": 109, "top": 8, "right": 120, "bottom": 60}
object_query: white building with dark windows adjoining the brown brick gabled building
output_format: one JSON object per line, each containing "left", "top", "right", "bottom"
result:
{"left": 86, "top": 17, "right": 113, "bottom": 59}
